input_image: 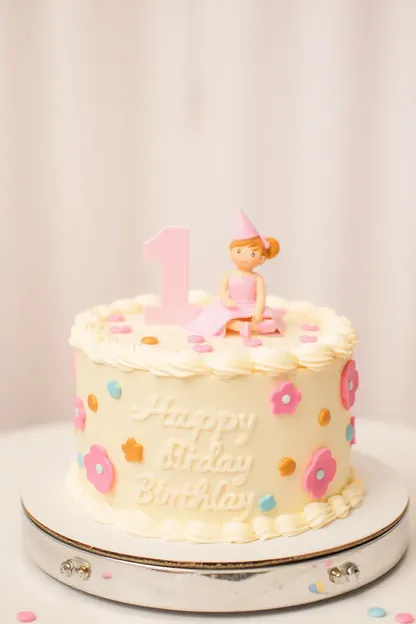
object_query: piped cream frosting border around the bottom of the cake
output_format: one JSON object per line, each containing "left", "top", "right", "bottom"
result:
{"left": 66, "top": 462, "right": 364, "bottom": 543}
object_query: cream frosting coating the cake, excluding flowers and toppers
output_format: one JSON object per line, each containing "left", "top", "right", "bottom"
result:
{"left": 68, "top": 291, "right": 363, "bottom": 543}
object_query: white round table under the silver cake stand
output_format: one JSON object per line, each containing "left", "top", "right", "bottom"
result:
{"left": 0, "top": 420, "right": 416, "bottom": 624}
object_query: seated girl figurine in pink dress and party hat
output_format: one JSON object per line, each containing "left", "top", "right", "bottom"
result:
{"left": 186, "top": 211, "right": 285, "bottom": 340}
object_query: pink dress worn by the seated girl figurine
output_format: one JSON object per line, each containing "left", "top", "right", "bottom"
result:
{"left": 186, "top": 273, "right": 285, "bottom": 336}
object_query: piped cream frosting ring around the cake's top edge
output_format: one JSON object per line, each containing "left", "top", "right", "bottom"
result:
{"left": 69, "top": 291, "right": 358, "bottom": 378}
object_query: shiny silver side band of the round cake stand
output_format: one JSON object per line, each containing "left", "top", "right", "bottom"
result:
{"left": 23, "top": 510, "right": 410, "bottom": 615}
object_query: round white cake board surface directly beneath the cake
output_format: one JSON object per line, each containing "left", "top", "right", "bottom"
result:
{"left": 22, "top": 452, "right": 409, "bottom": 568}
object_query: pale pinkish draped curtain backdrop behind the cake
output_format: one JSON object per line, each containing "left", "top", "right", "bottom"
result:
{"left": 0, "top": 0, "right": 416, "bottom": 428}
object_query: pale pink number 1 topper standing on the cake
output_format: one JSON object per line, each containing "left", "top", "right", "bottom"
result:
{"left": 143, "top": 226, "right": 199, "bottom": 325}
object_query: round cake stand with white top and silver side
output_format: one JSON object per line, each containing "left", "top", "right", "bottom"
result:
{"left": 22, "top": 450, "right": 409, "bottom": 613}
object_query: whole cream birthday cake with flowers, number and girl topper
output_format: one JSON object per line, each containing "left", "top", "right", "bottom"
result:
{"left": 67, "top": 213, "right": 363, "bottom": 542}
